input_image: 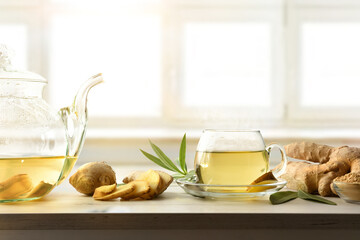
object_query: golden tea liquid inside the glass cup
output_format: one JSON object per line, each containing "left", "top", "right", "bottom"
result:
{"left": 195, "top": 150, "right": 269, "bottom": 185}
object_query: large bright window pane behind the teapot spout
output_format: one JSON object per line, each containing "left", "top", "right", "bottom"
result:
{"left": 49, "top": 14, "right": 161, "bottom": 116}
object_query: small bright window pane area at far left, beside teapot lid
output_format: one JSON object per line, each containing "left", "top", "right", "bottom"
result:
{"left": 0, "top": 24, "right": 28, "bottom": 70}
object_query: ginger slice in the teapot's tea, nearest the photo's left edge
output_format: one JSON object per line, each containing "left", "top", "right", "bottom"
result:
{"left": 0, "top": 174, "right": 33, "bottom": 199}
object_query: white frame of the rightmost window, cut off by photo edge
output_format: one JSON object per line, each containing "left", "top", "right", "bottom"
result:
{"left": 286, "top": 0, "right": 360, "bottom": 124}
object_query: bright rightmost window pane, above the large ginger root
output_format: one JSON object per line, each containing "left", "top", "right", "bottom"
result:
{"left": 300, "top": 22, "right": 360, "bottom": 107}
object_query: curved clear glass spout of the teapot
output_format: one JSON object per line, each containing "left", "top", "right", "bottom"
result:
{"left": 59, "top": 73, "right": 103, "bottom": 157}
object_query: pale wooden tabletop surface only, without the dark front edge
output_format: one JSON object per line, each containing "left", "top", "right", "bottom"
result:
{"left": 0, "top": 184, "right": 360, "bottom": 217}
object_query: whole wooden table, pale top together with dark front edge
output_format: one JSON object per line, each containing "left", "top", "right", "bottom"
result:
{"left": 0, "top": 166, "right": 360, "bottom": 230}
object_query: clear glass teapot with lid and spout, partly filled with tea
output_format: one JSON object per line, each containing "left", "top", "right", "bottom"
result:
{"left": 0, "top": 45, "right": 103, "bottom": 202}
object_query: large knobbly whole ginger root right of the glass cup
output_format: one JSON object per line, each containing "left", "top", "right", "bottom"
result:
{"left": 280, "top": 142, "right": 360, "bottom": 196}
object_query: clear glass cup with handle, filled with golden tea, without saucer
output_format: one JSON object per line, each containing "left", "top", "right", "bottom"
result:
{"left": 195, "top": 129, "right": 287, "bottom": 185}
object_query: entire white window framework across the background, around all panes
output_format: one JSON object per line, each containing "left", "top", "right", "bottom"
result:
{"left": 0, "top": 0, "right": 360, "bottom": 128}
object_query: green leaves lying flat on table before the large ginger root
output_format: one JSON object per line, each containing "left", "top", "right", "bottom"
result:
{"left": 269, "top": 190, "right": 337, "bottom": 205}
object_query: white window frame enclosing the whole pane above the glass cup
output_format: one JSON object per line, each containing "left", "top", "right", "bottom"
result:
{"left": 164, "top": 0, "right": 284, "bottom": 126}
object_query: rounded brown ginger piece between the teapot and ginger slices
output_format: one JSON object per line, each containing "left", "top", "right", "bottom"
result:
{"left": 69, "top": 162, "right": 116, "bottom": 195}
